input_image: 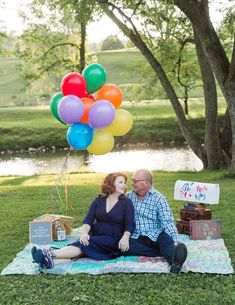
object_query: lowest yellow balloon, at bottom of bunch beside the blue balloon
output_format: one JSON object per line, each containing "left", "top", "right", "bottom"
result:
{"left": 87, "top": 129, "right": 114, "bottom": 155}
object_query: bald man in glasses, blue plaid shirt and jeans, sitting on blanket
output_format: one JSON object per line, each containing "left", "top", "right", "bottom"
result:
{"left": 126, "top": 169, "right": 187, "bottom": 274}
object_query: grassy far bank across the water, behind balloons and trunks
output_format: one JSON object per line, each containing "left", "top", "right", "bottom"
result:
{"left": 0, "top": 99, "right": 225, "bottom": 154}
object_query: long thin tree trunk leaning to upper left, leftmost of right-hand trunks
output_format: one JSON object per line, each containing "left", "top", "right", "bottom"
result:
{"left": 98, "top": 0, "right": 207, "bottom": 167}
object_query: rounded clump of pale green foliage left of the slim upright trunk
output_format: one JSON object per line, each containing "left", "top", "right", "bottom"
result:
{"left": 16, "top": 24, "right": 80, "bottom": 96}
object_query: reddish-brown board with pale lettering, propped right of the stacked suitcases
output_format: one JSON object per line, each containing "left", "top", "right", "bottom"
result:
{"left": 190, "top": 219, "right": 221, "bottom": 240}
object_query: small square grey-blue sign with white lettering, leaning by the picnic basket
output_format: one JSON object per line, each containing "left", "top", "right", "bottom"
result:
{"left": 29, "top": 221, "right": 52, "bottom": 244}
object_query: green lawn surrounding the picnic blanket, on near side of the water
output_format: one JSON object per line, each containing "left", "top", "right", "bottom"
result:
{"left": 0, "top": 171, "right": 235, "bottom": 305}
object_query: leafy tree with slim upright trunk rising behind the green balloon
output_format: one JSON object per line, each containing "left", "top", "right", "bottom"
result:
{"left": 17, "top": 0, "right": 97, "bottom": 93}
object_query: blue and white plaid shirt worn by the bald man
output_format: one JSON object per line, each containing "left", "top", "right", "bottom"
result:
{"left": 127, "top": 187, "right": 178, "bottom": 241}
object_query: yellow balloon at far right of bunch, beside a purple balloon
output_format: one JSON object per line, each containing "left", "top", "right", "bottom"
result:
{"left": 105, "top": 108, "right": 133, "bottom": 136}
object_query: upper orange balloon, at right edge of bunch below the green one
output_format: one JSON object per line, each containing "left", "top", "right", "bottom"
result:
{"left": 96, "top": 84, "right": 123, "bottom": 109}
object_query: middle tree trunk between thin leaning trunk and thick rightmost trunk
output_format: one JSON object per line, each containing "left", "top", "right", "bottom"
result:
{"left": 194, "top": 25, "right": 226, "bottom": 169}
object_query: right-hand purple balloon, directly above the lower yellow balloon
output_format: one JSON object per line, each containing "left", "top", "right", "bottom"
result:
{"left": 88, "top": 100, "right": 115, "bottom": 129}
